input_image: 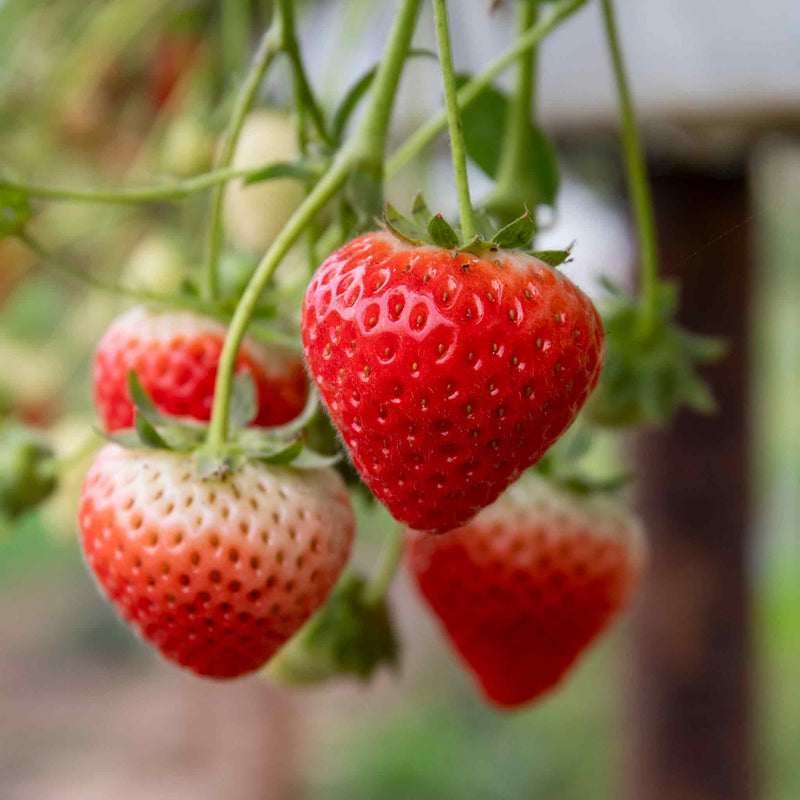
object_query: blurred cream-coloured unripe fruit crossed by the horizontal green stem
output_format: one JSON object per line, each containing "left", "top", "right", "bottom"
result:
{"left": 223, "top": 110, "right": 303, "bottom": 254}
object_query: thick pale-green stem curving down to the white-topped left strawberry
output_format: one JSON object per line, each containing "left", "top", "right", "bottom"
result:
{"left": 208, "top": 0, "right": 420, "bottom": 452}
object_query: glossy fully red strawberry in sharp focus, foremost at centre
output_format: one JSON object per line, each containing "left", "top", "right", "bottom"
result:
{"left": 303, "top": 233, "right": 604, "bottom": 532}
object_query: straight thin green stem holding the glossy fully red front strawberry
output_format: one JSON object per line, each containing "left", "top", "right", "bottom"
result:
{"left": 433, "top": 0, "right": 475, "bottom": 242}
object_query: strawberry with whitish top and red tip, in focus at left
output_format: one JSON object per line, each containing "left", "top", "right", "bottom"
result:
{"left": 79, "top": 445, "right": 355, "bottom": 678}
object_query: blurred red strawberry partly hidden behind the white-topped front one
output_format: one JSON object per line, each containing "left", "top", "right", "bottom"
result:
{"left": 94, "top": 306, "right": 307, "bottom": 431}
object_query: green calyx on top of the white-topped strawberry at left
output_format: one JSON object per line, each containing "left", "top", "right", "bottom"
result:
{"left": 106, "top": 371, "right": 340, "bottom": 478}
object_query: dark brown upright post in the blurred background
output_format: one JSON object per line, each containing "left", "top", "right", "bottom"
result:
{"left": 630, "top": 164, "right": 755, "bottom": 800}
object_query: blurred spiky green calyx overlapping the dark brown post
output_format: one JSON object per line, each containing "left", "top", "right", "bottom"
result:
{"left": 587, "top": 281, "right": 726, "bottom": 427}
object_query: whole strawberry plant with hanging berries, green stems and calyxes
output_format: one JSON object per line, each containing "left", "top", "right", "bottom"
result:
{"left": 0, "top": 0, "right": 721, "bottom": 720}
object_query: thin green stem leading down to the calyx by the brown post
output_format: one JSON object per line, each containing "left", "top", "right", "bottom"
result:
{"left": 602, "top": 0, "right": 658, "bottom": 335}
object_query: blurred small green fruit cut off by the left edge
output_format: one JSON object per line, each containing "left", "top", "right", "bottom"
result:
{"left": 0, "top": 420, "right": 56, "bottom": 520}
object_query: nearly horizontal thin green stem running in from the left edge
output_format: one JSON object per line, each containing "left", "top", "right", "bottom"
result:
{"left": 0, "top": 164, "right": 269, "bottom": 205}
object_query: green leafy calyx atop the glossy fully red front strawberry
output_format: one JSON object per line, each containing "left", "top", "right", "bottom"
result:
{"left": 381, "top": 193, "right": 572, "bottom": 267}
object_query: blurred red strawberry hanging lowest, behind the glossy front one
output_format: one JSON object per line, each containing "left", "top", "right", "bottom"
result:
{"left": 406, "top": 476, "right": 642, "bottom": 708}
